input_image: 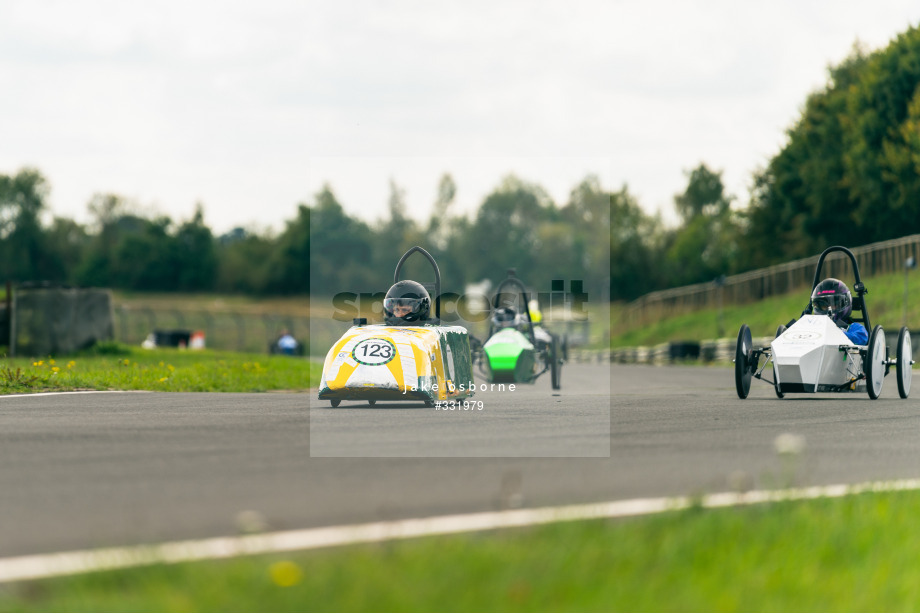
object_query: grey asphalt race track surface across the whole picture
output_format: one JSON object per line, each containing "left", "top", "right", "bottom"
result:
{"left": 0, "top": 365, "right": 920, "bottom": 557}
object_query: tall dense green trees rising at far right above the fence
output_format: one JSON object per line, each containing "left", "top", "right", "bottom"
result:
{"left": 740, "top": 27, "right": 920, "bottom": 268}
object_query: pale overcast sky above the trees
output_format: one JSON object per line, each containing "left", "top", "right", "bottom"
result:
{"left": 0, "top": 0, "right": 920, "bottom": 232}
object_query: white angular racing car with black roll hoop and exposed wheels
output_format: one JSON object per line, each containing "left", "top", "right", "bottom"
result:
{"left": 735, "top": 246, "right": 914, "bottom": 399}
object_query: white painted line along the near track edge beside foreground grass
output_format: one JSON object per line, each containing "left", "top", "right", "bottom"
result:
{"left": 0, "top": 479, "right": 920, "bottom": 582}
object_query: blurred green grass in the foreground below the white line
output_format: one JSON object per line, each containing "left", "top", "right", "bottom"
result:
{"left": 0, "top": 492, "right": 920, "bottom": 612}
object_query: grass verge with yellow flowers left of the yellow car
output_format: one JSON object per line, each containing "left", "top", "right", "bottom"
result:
{"left": 0, "top": 343, "right": 322, "bottom": 394}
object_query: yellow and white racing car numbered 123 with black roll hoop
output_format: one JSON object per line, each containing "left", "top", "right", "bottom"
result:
{"left": 319, "top": 246, "right": 475, "bottom": 407}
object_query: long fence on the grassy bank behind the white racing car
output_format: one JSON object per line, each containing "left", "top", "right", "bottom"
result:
{"left": 623, "top": 235, "right": 920, "bottom": 326}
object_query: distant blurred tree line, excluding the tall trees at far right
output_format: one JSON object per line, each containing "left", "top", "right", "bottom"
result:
{"left": 0, "top": 164, "right": 756, "bottom": 300}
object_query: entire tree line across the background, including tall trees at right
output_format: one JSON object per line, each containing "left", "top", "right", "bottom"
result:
{"left": 0, "top": 28, "right": 920, "bottom": 300}
